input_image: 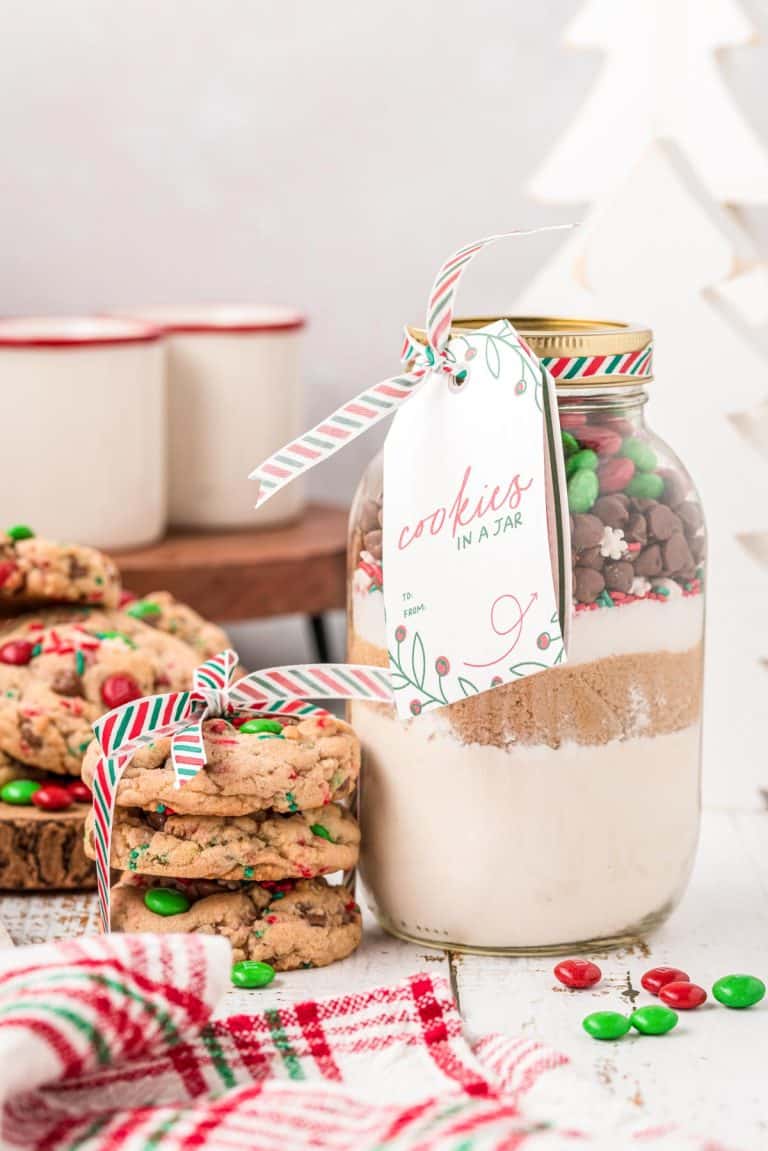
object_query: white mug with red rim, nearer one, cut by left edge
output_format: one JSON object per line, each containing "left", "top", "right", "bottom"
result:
{"left": 0, "top": 317, "right": 167, "bottom": 548}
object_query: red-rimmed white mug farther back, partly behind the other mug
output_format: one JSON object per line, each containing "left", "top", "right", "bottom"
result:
{"left": 115, "top": 305, "right": 305, "bottom": 527}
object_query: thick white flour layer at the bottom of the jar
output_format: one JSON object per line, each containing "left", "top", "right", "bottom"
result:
{"left": 351, "top": 704, "right": 699, "bottom": 948}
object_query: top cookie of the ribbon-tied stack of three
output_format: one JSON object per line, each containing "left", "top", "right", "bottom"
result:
{"left": 83, "top": 716, "right": 360, "bottom": 816}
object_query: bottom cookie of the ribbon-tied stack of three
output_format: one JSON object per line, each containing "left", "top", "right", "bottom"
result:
{"left": 112, "top": 876, "right": 362, "bottom": 971}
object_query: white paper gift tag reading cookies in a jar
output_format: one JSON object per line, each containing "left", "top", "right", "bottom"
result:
{"left": 383, "top": 320, "right": 571, "bottom": 717}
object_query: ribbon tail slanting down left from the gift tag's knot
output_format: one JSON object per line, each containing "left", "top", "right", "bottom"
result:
{"left": 249, "top": 371, "right": 425, "bottom": 509}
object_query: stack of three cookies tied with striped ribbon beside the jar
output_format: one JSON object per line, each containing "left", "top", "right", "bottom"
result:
{"left": 83, "top": 716, "right": 362, "bottom": 970}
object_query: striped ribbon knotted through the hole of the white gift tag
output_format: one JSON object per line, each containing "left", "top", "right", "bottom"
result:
{"left": 249, "top": 224, "right": 571, "bottom": 508}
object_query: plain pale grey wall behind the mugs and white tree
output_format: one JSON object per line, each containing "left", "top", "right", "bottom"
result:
{"left": 0, "top": 0, "right": 768, "bottom": 667}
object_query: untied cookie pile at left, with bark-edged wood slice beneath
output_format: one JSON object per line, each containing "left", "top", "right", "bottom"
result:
{"left": 0, "top": 525, "right": 229, "bottom": 890}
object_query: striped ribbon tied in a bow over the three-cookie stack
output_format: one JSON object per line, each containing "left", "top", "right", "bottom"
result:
{"left": 93, "top": 649, "right": 393, "bottom": 931}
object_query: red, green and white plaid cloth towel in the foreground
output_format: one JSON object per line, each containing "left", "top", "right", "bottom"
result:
{"left": 0, "top": 935, "right": 736, "bottom": 1151}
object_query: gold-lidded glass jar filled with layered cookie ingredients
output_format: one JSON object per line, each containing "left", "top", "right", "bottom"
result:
{"left": 348, "top": 318, "right": 706, "bottom": 953}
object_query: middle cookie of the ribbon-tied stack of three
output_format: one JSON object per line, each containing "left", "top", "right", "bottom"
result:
{"left": 85, "top": 801, "right": 360, "bottom": 882}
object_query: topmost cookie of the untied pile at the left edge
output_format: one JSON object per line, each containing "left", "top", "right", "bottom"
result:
{"left": 0, "top": 524, "right": 121, "bottom": 612}
